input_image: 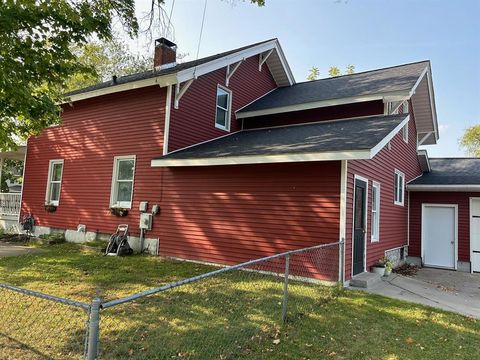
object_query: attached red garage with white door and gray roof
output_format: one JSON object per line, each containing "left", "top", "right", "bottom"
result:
{"left": 407, "top": 156, "right": 480, "bottom": 273}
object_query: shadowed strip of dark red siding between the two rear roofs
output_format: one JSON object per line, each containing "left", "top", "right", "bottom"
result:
{"left": 243, "top": 100, "right": 384, "bottom": 129}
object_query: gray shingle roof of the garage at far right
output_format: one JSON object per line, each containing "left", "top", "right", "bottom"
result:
{"left": 409, "top": 158, "right": 480, "bottom": 185}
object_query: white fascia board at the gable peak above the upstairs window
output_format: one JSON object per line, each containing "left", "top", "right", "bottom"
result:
{"left": 177, "top": 40, "right": 293, "bottom": 84}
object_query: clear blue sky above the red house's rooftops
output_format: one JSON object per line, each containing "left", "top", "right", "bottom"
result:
{"left": 137, "top": 0, "right": 480, "bottom": 157}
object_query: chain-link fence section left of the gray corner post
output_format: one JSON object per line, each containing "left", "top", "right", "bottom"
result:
{"left": 0, "top": 284, "right": 90, "bottom": 359}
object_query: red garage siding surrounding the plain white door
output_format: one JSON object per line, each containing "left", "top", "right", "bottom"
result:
{"left": 408, "top": 191, "right": 480, "bottom": 261}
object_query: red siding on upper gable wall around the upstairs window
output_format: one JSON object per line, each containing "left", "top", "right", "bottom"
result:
{"left": 168, "top": 56, "right": 276, "bottom": 151}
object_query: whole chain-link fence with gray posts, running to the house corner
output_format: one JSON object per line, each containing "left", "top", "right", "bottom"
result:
{"left": 0, "top": 242, "right": 343, "bottom": 359}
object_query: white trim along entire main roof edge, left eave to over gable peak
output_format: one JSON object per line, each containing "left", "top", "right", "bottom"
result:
{"left": 64, "top": 39, "right": 295, "bottom": 103}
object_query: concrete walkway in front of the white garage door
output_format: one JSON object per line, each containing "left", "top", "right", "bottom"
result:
{"left": 355, "top": 268, "right": 480, "bottom": 319}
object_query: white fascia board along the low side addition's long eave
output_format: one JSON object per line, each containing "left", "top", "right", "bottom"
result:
{"left": 151, "top": 150, "right": 370, "bottom": 167}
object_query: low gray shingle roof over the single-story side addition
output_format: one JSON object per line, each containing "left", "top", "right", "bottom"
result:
{"left": 158, "top": 115, "right": 406, "bottom": 160}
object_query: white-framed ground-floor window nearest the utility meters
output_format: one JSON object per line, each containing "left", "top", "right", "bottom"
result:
{"left": 110, "top": 155, "right": 135, "bottom": 209}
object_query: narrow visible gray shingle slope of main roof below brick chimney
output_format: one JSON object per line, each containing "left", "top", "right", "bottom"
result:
{"left": 65, "top": 39, "right": 275, "bottom": 96}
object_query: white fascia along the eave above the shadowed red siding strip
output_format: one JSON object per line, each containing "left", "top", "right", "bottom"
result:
{"left": 236, "top": 91, "right": 408, "bottom": 119}
